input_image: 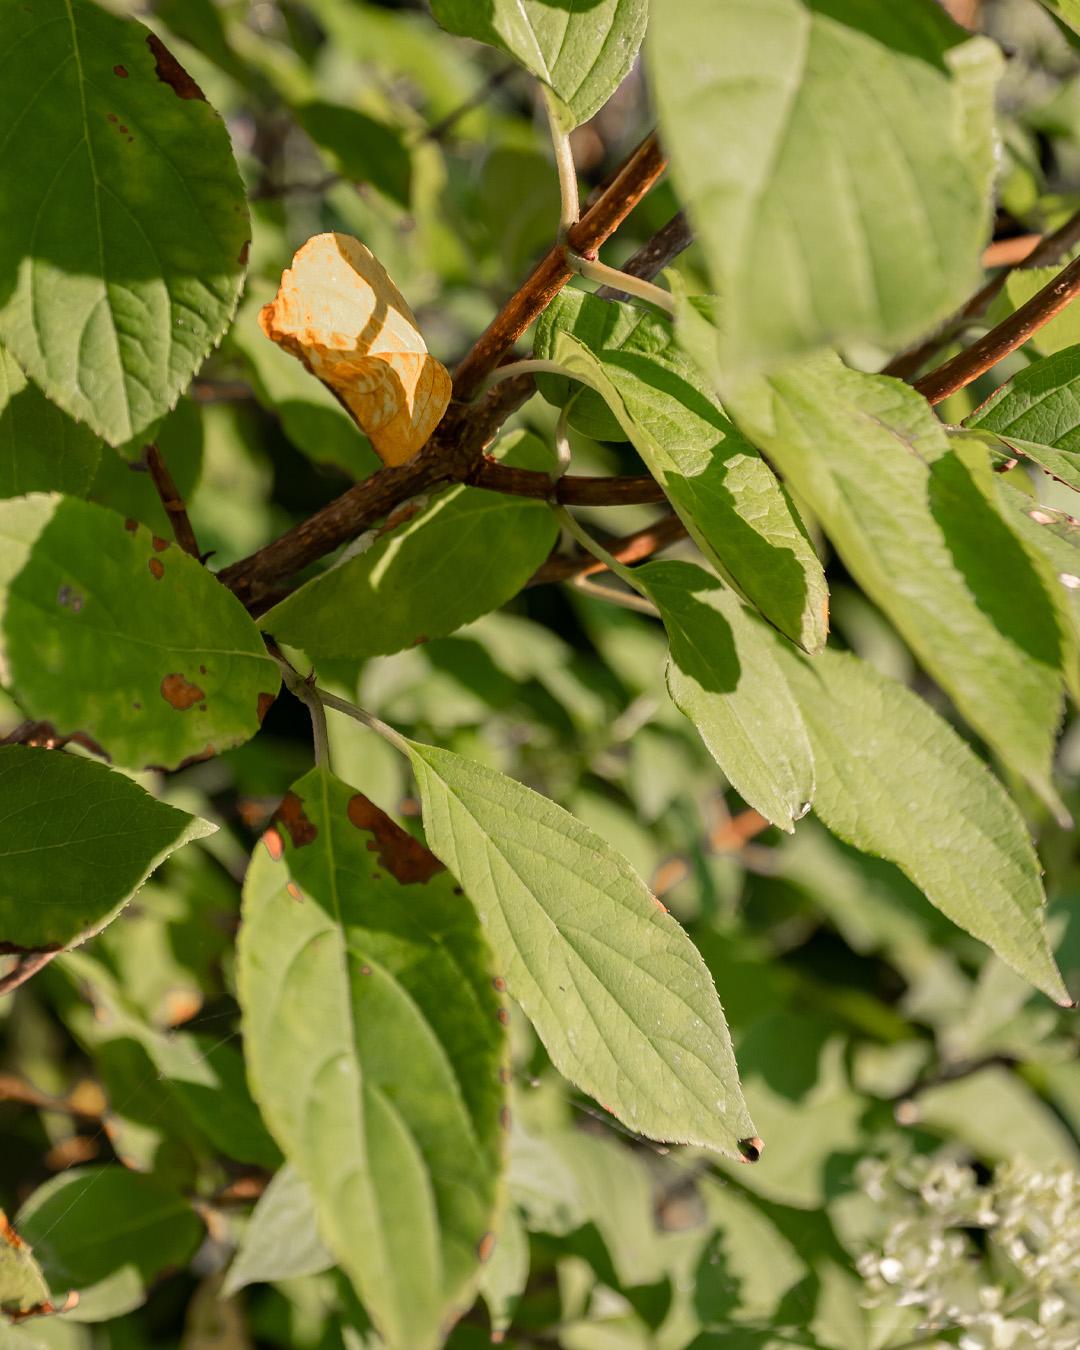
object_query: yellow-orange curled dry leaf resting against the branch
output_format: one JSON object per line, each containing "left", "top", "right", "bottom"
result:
{"left": 259, "top": 234, "right": 451, "bottom": 464}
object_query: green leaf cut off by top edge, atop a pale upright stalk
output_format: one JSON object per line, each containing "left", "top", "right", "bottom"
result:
{"left": 431, "top": 0, "right": 648, "bottom": 130}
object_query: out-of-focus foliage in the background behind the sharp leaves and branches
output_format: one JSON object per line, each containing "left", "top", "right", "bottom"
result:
{"left": 0, "top": 0, "right": 1080, "bottom": 1350}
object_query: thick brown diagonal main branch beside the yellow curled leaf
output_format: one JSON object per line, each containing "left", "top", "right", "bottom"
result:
{"left": 217, "top": 135, "right": 666, "bottom": 613}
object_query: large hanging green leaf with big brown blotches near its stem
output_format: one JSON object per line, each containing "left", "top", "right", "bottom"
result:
{"left": 239, "top": 770, "right": 506, "bottom": 1350}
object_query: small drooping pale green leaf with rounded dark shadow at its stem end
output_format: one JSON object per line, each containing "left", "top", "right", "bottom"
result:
{"left": 633, "top": 562, "right": 814, "bottom": 832}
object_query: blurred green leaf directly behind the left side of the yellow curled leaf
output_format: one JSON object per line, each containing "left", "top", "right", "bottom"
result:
{"left": 228, "top": 298, "right": 382, "bottom": 479}
